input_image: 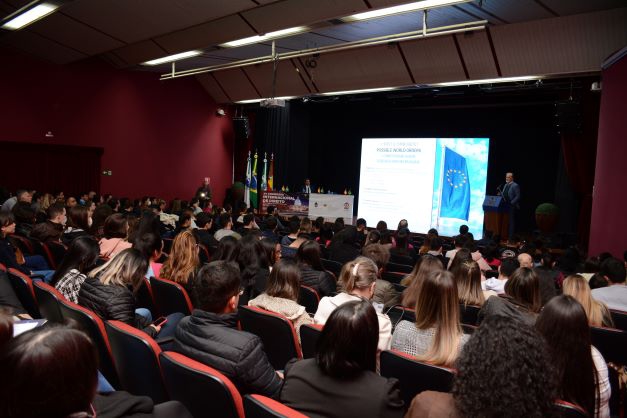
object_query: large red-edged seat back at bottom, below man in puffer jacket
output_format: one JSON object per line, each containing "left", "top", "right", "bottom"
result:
{"left": 159, "top": 351, "right": 244, "bottom": 418}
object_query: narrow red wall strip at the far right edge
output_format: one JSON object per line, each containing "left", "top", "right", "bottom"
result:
{"left": 589, "top": 53, "right": 627, "bottom": 258}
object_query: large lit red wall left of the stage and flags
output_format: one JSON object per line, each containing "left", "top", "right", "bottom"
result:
{"left": 0, "top": 50, "right": 233, "bottom": 205}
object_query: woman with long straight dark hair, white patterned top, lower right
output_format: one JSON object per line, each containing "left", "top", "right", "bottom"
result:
{"left": 536, "top": 295, "right": 611, "bottom": 418}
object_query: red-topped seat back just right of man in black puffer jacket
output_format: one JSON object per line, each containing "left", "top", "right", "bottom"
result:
{"left": 238, "top": 306, "right": 303, "bottom": 370}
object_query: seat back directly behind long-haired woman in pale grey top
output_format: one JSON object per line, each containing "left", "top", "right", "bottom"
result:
{"left": 381, "top": 351, "right": 455, "bottom": 405}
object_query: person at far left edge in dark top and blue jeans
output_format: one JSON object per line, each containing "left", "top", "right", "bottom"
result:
{"left": 0, "top": 212, "right": 54, "bottom": 282}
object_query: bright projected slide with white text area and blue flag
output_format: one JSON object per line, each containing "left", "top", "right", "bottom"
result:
{"left": 357, "top": 138, "right": 490, "bottom": 238}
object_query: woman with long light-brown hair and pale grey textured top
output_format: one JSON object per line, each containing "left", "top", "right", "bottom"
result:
{"left": 392, "top": 270, "right": 469, "bottom": 367}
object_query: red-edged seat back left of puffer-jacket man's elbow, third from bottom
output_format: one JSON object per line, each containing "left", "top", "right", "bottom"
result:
{"left": 105, "top": 321, "right": 169, "bottom": 403}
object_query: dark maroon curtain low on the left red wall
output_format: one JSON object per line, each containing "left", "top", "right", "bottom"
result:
{"left": 0, "top": 142, "right": 103, "bottom": 196}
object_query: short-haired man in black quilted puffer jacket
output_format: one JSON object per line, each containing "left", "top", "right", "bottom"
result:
{"left": 172, "top": 261, "right": 281, "bottom": 398}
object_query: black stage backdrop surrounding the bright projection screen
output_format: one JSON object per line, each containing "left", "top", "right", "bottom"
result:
{"left": 254, "top": 85, "right": 600, "bottom": 238}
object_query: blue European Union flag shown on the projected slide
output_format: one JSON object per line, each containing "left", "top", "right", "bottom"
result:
{"left": 440, "top": 147, "right": 470, "bottom": 221}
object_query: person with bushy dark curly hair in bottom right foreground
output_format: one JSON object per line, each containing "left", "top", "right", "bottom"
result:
{"left": 405, "top": 316, "right": 557, "bottom": 418}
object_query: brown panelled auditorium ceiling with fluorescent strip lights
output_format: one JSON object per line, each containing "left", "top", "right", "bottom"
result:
{"left": 0, "top": 0, "right": 627, "bottom": 102}
